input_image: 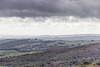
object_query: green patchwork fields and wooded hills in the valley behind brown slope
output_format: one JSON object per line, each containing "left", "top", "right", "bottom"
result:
{"left": 0, "top": 39, "right": 100, "bottom": 57}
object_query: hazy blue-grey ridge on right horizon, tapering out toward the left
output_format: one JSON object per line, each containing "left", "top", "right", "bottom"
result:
{"left": 37, "top": 34, "right": 100, "bottom": 41}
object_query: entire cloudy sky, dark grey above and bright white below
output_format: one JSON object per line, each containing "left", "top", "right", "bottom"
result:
{"left": 0, "top": 0, "right": 100, "bottom": 35}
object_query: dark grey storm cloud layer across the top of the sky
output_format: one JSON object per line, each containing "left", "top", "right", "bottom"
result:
{"left": 0, "top": 0, "right": 100, "bottom": 18}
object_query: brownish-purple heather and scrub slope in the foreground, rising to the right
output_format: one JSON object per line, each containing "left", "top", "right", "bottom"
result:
{"left": 0, "top": 44, "right": 100, "bottom": 67}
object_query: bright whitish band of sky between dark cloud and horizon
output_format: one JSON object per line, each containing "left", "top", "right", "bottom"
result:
{"left": 0, "top": 16, "right": 100, "bottom": 35}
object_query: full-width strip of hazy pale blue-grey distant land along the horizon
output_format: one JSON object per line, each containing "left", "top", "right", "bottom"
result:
{"left": 0, "top": 34, "right": 100, "bottom": 41}
